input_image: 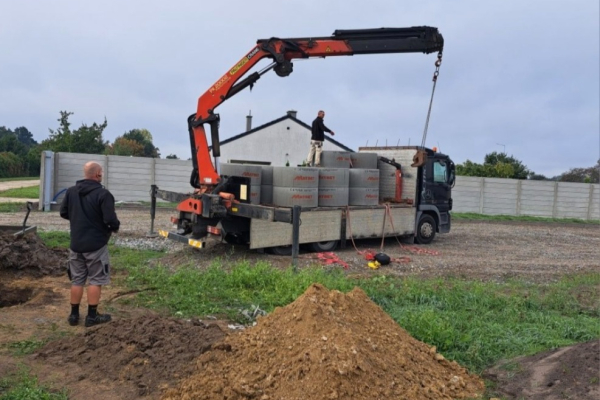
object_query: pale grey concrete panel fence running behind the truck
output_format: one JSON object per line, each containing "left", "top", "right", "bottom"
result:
{"left": 40, "top": 153, "right": 600, "bottom": 220}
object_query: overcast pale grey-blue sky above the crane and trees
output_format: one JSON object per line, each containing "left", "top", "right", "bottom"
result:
{"left": 0, "top": 0, "right": 600, "bottom": 177}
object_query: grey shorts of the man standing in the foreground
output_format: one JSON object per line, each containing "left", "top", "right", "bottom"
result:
{"left": 69, "top": 246, "right": 110, "bottom": 286}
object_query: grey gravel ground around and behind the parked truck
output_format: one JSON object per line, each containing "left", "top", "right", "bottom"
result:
{"left": 0, "top": 208, "right": 600, "bottom": 282}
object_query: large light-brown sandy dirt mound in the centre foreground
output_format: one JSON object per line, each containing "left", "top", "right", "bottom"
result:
{"left": 163, "top": 284, "right": 484, "bottom": 400}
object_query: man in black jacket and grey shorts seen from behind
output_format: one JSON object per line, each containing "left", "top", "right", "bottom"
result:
{"left": 60, "top": 161, "right": 121, "bottom": 327}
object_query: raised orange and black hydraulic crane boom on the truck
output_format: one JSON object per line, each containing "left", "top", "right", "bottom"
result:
{"left": 189, "top": 26, "right": 444, "bottom": 189}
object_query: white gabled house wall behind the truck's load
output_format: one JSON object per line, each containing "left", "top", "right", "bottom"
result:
{"left": 220, "top": 119, "right": 346, "bottom": 166}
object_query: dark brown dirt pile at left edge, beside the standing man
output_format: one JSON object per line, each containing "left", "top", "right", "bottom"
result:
{"left": 0, "top": 233, "right": 68, "bottom": 277}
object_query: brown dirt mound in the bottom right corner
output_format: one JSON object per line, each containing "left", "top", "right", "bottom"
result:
{"left": 485, "top": 340, "right": 600, "bottom": 400}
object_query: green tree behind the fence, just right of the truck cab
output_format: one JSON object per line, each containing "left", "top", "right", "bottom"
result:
{"left": 456, "top": 152, "right": 532, "bottom": 179}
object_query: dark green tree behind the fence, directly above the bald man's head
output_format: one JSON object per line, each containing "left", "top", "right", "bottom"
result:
{"left": 41, "top": 111, "right": 108, "bottom": 154}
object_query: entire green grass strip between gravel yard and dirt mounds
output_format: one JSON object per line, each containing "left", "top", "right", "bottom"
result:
{"left": 111, "top": 245, "right": 600, "bottom": 373}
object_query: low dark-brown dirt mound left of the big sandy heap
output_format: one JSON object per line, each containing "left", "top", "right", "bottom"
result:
{"left": 36, "top": 315, "right": 226, "bottom": 396}
